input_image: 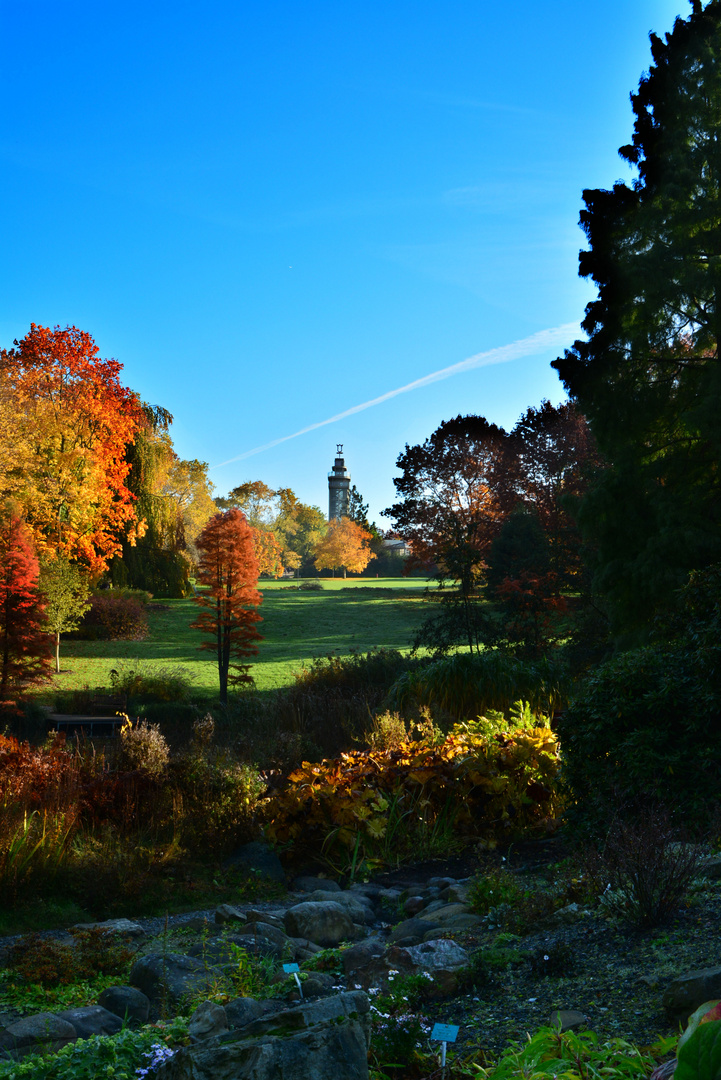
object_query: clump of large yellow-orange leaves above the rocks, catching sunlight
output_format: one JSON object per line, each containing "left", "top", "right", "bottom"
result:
{"left": 267, "top": 726, "right": 560, "bottom": 874}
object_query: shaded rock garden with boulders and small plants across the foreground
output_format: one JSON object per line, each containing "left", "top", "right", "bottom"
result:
{"left": 0, "top": 836, "right": 721, "bottom": 1080}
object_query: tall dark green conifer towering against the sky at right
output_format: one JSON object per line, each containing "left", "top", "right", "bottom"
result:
{"left": 554, "top": 0, "right": 721, "bottom": 645}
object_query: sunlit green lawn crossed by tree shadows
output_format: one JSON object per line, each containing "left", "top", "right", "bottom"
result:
{"left": 41, "top": 578, "right": 436, "bottom": 700}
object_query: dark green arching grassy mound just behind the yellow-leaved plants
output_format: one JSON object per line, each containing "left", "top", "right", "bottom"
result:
{"left": 387, "top": 650, "right": 568, "bottom": 718}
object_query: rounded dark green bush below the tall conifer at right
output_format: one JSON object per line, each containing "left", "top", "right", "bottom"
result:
{"left": 558, "top": 646, "right": 721, "bottom": 827}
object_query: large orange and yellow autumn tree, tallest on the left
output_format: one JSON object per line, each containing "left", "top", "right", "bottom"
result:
{"left": 0, "top": 323, "right": 142, "bottom": 573}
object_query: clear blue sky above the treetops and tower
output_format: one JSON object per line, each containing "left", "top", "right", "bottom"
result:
{"left": 0, "top": 0, "right": 690, "bottom": 527}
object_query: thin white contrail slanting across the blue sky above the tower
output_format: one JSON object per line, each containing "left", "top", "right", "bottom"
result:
{"left": 212, "top": 323, "right": 580, "bottom": 469}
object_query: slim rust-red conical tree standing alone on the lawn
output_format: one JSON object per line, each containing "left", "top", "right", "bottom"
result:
{"left": 191, "top": 510, "right": 262, "bottom": 704}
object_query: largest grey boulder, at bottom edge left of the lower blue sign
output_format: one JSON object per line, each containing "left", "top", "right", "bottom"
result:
{"left": 157, "top": 994, "right": 369, "bottom": 1080}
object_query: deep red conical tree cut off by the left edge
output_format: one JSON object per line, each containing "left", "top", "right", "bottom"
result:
{"left": 0, "top": 509, "right": 51, "bottom": 703}
